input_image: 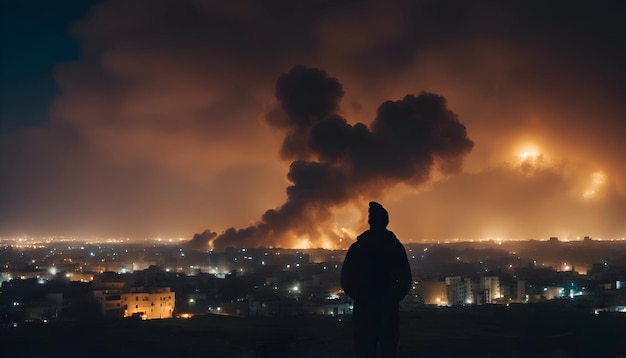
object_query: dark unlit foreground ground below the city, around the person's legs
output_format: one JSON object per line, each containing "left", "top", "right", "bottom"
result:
{"left": 0, "top": 305, "right": 626, "bottom": 358}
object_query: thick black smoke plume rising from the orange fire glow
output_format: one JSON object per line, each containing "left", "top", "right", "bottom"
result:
{"left": 193, "top": 66, "right": 473, "bottom": 250}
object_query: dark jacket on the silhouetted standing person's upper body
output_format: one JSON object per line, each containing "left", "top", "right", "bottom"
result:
{"left": 341, "top": 229, "right": 411, "bottom": 309}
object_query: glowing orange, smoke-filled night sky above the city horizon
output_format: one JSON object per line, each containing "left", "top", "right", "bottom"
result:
{"left": 0, "top": 0, "right": 626, "bottom": 248}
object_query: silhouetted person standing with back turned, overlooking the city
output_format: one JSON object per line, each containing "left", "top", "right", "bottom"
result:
{"left": 341, "top": 202, "right": 411, "bottom": 358}
